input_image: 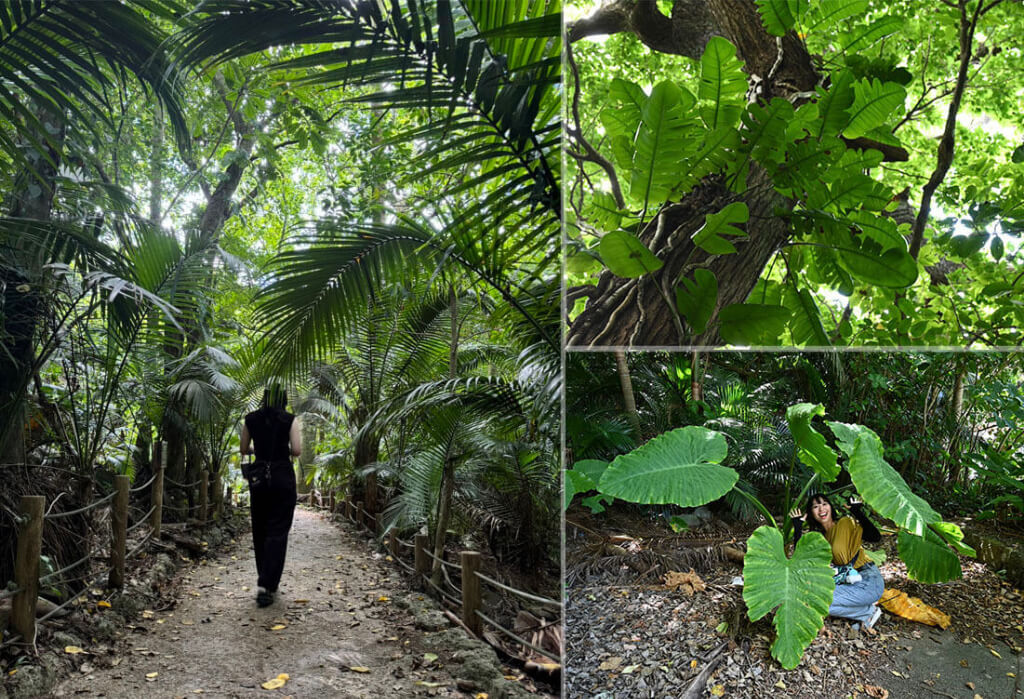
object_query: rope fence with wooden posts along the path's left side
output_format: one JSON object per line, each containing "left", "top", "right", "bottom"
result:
{"left": 0, "top": 442, "right": 220, "bottom": 648}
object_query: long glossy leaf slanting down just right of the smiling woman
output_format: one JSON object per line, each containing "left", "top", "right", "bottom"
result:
{"left": 827, "top": 422, "right": 942, "bottom": 536}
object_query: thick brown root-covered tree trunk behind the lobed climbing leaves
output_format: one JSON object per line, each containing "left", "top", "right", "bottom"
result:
{"left": 567, "top": 0, "right": 818, "bottom": 347}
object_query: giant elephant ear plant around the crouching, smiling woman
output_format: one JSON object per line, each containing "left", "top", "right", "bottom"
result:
{"left": 565, "top": 403, "right": 974, "bottom": 669}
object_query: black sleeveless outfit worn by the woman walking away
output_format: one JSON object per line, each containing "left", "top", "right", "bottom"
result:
{"left": 246, "top": 407, "right": 296, "bottom": 593}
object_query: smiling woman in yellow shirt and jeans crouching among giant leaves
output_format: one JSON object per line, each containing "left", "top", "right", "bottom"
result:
{"left": 790, "top": 494, "right": 885, "bottom": 628}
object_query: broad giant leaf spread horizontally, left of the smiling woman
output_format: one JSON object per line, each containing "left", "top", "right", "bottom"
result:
{"left": 598, "top": 426, "right": 739, "bottom": 508}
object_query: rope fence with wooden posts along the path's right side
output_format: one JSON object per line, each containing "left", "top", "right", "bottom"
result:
{"left": 310, "top": 492, "right": 562, "bottom": 663}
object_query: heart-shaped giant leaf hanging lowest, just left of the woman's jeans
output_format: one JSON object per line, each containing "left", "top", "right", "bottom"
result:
{"left": 743, "top": 526, "right": 836, "bottom": 669}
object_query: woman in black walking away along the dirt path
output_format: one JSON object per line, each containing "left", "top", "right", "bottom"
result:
{"left": 242, "top": 384, "right": 302, "bottom": 607}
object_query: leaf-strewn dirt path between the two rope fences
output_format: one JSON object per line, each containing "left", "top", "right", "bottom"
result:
{"left": 53, "top": 508, "right": 521, "bottom": 699}
